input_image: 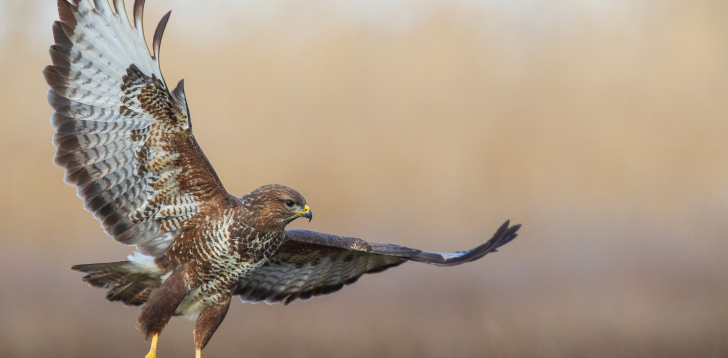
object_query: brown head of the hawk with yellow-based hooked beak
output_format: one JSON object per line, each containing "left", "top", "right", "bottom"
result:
{"left": 246, "top": 184, "right": 313, "bottom": 225}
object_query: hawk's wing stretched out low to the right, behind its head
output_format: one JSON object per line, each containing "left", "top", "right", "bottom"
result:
{"left": 234, "top": 221, "right": 521, "bottom": 305}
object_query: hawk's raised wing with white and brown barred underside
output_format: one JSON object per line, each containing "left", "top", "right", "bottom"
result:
{"left": 43, "top": 0, "right": 238, "bottom": 255}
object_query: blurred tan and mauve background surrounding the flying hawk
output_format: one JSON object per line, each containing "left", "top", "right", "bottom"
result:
{"left": 0, "top": 0, "right": 728, "bottom": 358}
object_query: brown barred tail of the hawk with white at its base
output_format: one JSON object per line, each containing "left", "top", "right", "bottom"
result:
{"left": 71, "top": 253, "right": 169, "bottom": 306}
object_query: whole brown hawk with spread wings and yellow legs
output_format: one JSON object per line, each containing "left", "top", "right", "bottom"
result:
{"left": 43, "top": 0, "right": 520, "bottom": 358}
